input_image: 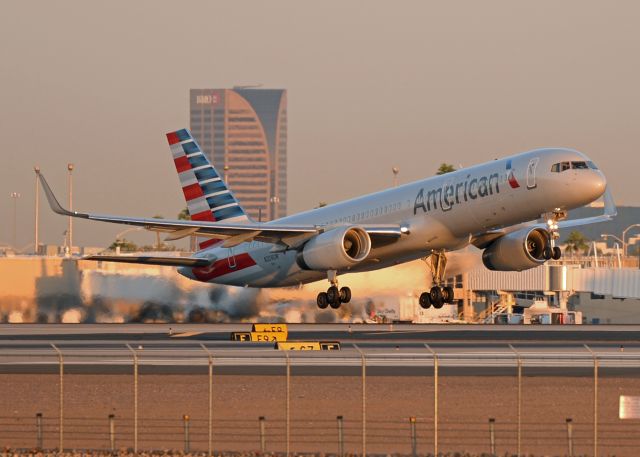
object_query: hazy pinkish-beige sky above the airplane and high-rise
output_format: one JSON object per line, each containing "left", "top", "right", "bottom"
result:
{"left": 0, "top": 0, "right": 640, "bottom": 249}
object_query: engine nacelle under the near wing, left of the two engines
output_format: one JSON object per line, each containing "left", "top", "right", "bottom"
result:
{"left": 297, "top": 226, "right": 371, "bottom": 270}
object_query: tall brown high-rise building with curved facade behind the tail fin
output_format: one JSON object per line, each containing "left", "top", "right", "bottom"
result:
{"left": 190, "top": 87, "right": 287, "bottom": 221}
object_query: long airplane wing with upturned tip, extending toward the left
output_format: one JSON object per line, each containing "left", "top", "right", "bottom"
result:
{"left": 38, "top": 173, "right": 408, "bottom": 248}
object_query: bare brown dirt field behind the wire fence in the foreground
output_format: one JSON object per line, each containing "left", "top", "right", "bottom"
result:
{"left": 0, "top": 373, "right": 640, "bottom": 456}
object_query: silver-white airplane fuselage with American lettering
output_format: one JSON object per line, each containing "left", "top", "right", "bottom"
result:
{"left": 179, "top": 149, "right": 606, "bottom": 287}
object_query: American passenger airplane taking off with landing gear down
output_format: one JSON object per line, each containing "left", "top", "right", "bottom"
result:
{"left": 39, "top": 129, "right": 616, "bottom": 309}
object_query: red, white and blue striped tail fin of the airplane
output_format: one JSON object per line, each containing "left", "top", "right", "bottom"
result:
{"left": 167, "top": 129, "right": 249, "bottom": 249}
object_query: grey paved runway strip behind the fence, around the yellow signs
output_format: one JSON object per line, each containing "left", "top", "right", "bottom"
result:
{"left": 0, "top": 324, "right": 640, "bottom": 376}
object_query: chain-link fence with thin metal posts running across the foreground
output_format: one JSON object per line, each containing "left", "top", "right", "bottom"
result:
{"left": 0, "top": 344, "right": 640, "bottom": 456}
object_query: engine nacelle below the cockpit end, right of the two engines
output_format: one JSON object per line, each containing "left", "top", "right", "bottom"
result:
{"left": 482, "top": 228, "right": 550, "bottom": 271}
